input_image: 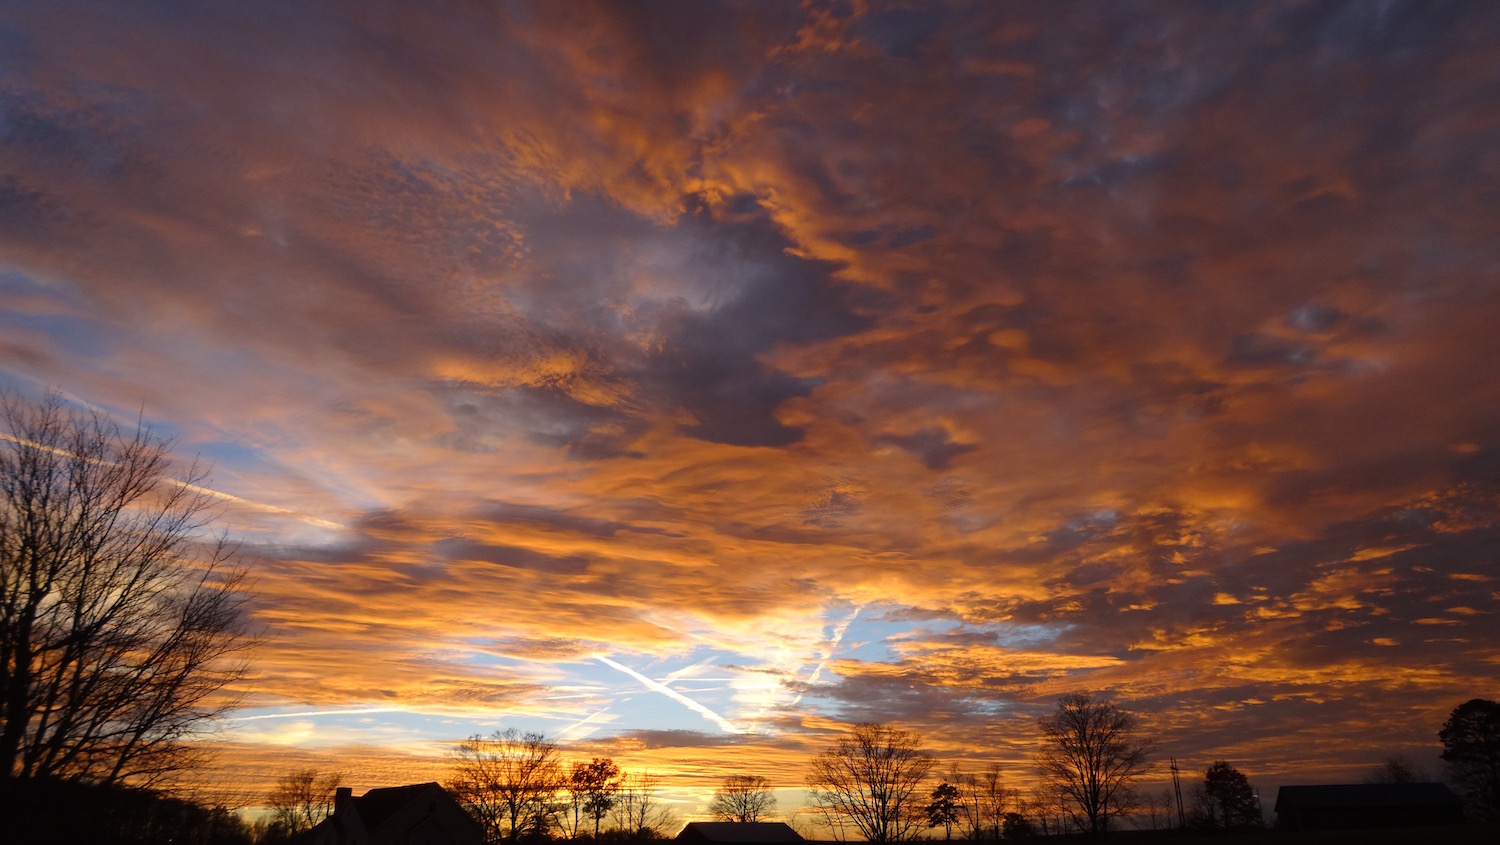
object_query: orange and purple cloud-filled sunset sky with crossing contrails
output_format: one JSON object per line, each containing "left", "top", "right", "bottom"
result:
{"left": 0, "top": 0, "right": 1500, "bottom": 813}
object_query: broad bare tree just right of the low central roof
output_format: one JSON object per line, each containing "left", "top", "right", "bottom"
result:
{"left": 807, "top": 725, "right": 938, "bottom": 842}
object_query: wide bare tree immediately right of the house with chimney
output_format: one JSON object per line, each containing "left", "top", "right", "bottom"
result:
{"left": 449, "top": 728, "right": 564, "bottom": 843}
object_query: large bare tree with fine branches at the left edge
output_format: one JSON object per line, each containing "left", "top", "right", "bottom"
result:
{"left": 0, "top": 396, "right": 249, "bottom": 785}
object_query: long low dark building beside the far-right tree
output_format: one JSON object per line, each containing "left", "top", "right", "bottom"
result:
{"left": 1277, "top": 783, "right": 1464, "bottom": 830}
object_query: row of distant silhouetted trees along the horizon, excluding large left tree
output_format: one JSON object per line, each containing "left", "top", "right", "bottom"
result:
{"left": 261, "top": 693, "right": 1500, "bottom": 845}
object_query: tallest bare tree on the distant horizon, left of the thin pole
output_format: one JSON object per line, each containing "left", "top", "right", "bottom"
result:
{"left": 1037, "top": 693, "right": 1154, "bottom": 834}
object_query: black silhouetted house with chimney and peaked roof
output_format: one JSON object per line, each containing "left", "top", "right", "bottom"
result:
{"left": 307, "top": 783, "right": 485, "bottom": 845}
